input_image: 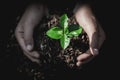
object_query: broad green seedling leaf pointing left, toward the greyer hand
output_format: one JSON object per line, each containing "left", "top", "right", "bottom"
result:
{"left": 46, "top": 27, "right": 63, "bottom": 39}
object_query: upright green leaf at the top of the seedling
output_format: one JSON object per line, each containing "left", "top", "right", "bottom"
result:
{"left": 60, "top": 14, "right": 68, "bottom": 31}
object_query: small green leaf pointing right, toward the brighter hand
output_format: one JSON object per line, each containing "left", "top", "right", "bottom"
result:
{"left": 68, "top": 25, "right": 82, "bottom": 37}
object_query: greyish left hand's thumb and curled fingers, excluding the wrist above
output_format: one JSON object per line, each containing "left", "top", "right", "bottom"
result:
{"left": 15, "top": 23, "right": 39, "bottom": 63}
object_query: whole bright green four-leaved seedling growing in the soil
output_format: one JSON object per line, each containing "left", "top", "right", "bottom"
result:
{"left": 46, "top": 14, "right": 82, "bottom": 49}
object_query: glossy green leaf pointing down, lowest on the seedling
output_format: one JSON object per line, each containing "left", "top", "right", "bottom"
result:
{"left": 60, "top": 34, "right": 70, "bottom": 49}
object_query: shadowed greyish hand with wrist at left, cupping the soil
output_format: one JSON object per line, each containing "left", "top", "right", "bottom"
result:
{"left": 15, "top": 4, "right": 45, "bottom": 63}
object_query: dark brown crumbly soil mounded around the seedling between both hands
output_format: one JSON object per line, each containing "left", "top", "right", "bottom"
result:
{"left": 35, "top": 15, "right": 88, "bottom": 68}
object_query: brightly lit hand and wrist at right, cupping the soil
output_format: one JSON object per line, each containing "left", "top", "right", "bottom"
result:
{"left": 75, "top": 5, "right": 105, "bottom": 66}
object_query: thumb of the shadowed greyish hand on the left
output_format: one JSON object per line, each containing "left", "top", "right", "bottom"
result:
{"left": 24, "top": 27, "right": 34, "bottom": 51}
